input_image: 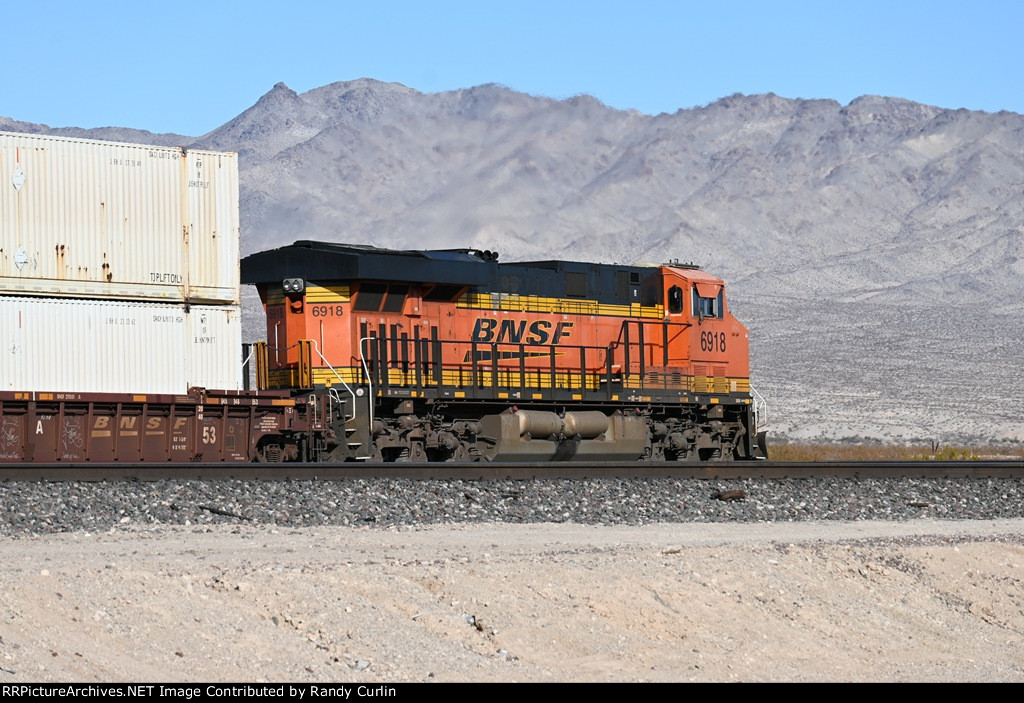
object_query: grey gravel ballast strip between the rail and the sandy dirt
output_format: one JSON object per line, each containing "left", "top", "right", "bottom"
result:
{"left": 0, "top": 479, "right": 1024, "bottom": 535}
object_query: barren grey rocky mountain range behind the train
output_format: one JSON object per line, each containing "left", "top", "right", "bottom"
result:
{"left": 0, "top": 79, "right": 1024, "bottom": 442}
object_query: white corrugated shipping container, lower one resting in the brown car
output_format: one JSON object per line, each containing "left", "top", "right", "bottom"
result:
{"left": 0, "top": 296, "right": 242, "bottom": 394}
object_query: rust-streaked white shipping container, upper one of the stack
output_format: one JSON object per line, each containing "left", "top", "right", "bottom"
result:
{"left": 0, "top": 132, "right": 240, "bottom": 303}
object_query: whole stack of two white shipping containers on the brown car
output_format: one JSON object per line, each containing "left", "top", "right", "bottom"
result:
{"left": 0, "top": 132, "right": 242, "bottom": 394}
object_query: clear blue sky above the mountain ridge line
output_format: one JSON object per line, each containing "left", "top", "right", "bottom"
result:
{"left": 8, "top": 0, "right": 1024, "bottom": 135}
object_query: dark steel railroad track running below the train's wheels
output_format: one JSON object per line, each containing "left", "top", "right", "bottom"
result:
{"left": 0, "top": 459, "right": 1024, "bottom": 481}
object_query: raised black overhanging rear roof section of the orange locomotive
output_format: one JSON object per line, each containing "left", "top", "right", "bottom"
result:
{"left": 242, "top": 240, "right": 497, "bottom": 285}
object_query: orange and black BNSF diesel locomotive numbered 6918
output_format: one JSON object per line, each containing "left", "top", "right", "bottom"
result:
{"left": 242, "top": 241, "right": 764, "bottom": 462}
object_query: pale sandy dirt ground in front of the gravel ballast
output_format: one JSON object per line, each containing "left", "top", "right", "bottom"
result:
{"left": 0, "top": 520, "right": 1024, "bottom": 684}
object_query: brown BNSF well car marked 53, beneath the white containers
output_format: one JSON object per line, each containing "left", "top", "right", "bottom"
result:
{"left": 0, "top": 389, "right": 329, "bottom": 464}
